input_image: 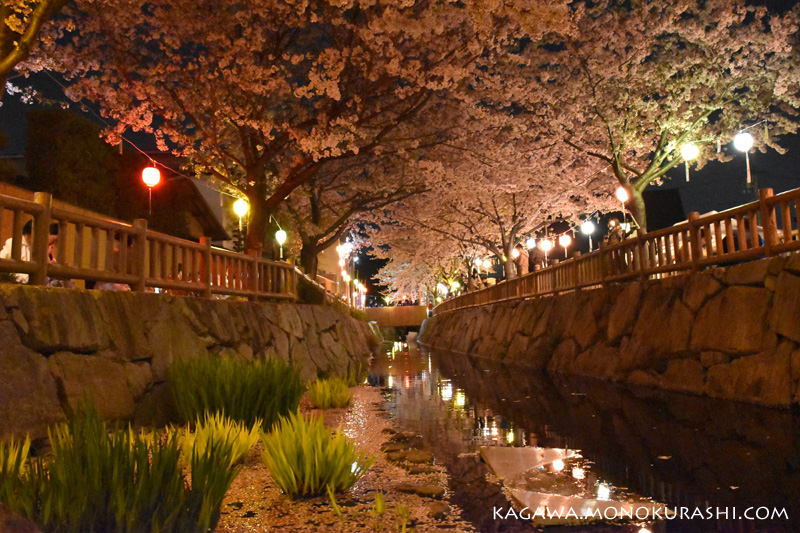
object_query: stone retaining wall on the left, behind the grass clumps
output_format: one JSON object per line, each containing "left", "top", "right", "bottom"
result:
{"left": 0, "top": 284, "right": 377, "bottom": 437}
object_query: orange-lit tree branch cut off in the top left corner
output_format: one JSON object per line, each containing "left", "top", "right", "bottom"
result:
{"left": 0, "top": 0, "right": 68, "bottom": 100}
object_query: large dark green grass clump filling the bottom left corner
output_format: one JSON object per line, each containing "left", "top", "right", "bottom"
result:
{"left": 0, "top": 409, "right": 238, "bottom": 533}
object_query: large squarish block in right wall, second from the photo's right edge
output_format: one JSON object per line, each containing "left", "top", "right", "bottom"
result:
{"left": 691, "top": 286, "right": 771, "bottom": 354}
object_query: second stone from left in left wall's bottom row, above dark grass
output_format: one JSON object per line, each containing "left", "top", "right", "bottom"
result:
{"left": 48, "top": 352, "right": 136, "bottom": 420}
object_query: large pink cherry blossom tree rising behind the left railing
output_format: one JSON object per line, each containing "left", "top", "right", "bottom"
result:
{"left": 40, "top": 0, "right": 569, "bottom": 249}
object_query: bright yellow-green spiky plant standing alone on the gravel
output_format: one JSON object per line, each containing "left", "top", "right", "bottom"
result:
{"left": 261, "top": 413, "right": 375, "bottom": 498}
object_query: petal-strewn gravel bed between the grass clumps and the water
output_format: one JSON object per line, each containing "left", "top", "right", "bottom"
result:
{"left": 217, "top": 386, "right": 475, "bottom": 532}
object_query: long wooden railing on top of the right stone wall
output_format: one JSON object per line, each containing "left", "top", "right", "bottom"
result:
{"left": 435, "top": 189, "right": 800, "bottom": 313}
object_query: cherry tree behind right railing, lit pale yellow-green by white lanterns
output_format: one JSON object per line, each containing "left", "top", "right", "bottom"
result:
{"left": 490, "top": 0, "right": 800, "bottom": 227}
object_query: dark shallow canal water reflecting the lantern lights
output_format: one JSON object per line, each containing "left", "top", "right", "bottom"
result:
{"left": 370, "top": 343, "right": 800, "bottom": 533}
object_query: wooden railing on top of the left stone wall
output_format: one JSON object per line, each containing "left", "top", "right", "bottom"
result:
{"left": 0, "top": 193, "right": 302, "bottom": 300}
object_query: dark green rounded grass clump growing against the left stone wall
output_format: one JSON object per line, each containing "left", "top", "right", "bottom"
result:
{"left": 169, "top": 357, "right": 305, "bottom": 430}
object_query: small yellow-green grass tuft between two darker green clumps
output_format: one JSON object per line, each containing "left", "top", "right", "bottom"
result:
{"left": 167, "top": 412, "right": 261, "bottom": 468}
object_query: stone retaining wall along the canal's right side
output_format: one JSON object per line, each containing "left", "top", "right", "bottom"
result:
{"left": 420, "top": 254, "right": 800, "bottom": 406}
